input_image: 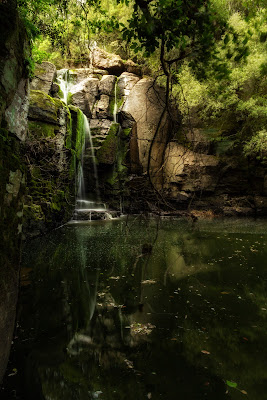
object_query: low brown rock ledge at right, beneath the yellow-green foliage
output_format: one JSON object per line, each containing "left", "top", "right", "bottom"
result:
{"left": 163, "top": 130, "right": 267, "bottom": 216}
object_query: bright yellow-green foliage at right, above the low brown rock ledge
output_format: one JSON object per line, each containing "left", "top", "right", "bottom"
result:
{"left": 173, "top": 10, "right": 267, "bottom": 156}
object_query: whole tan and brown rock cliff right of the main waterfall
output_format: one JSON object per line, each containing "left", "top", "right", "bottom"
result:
{"left": 50, "top": 60, "right": 265, "bottom": 214}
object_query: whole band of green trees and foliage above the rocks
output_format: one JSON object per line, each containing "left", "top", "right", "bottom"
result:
{"left": 19, "top": 0, "right": 267, "bottom": 164}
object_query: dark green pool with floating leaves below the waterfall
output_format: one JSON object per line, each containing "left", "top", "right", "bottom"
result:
{"left": 1, "top": 219, "right": 267, "bottom": 400}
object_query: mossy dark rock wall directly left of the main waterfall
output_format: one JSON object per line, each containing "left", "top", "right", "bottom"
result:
{"left": 24, "top": 90, "right": 85, "bottom": 237}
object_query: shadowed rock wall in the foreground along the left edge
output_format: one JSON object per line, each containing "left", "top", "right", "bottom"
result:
{"left": 0, "top": 0, "right": 29, "bottom": 382}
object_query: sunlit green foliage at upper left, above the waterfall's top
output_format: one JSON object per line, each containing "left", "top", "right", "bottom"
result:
{"left": 18, "top": 0, "right": 131, "bottom": 68}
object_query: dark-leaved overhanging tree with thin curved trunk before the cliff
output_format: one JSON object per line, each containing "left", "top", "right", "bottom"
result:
{"left": 118, "top": 0, "right": 251, "bottom": 196}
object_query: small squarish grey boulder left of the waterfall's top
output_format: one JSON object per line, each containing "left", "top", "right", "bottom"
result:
{"left": 31, "top": 61, "right": 57, "bottom": 94}
